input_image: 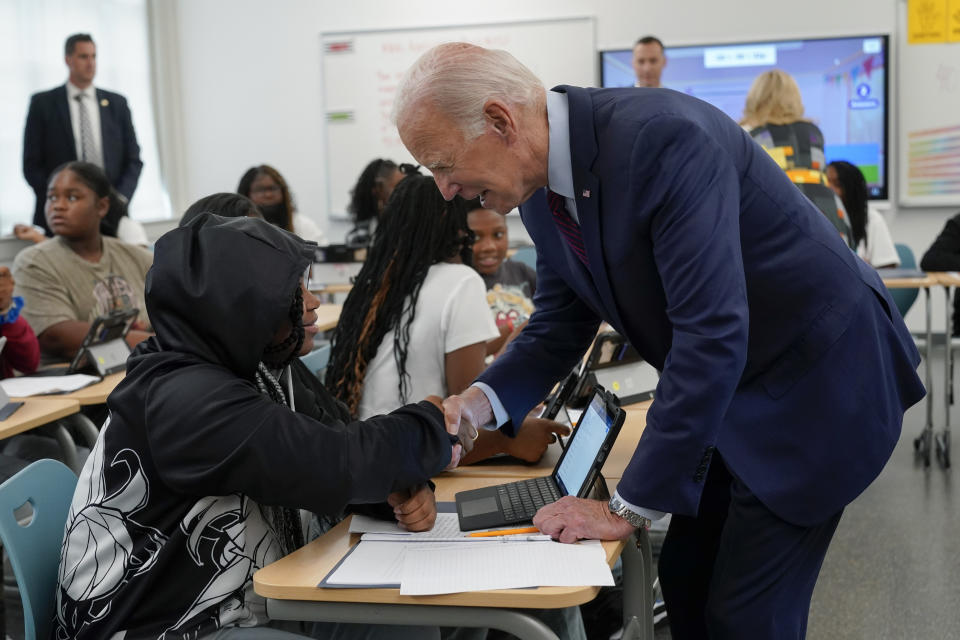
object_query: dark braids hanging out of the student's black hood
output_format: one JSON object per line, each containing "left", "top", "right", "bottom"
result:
{"left": 254, "top": 284, "right": 304, "bottom": 555}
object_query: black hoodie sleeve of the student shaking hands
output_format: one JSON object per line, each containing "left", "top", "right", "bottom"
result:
{"left": 142, "top": 364, "right": 451, "bottom": 514}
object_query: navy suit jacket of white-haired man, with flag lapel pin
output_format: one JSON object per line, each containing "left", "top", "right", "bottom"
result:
{"left": 480, "top": 87, "right": 924, "bottom": 525}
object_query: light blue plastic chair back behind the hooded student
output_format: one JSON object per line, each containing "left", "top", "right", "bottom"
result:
{"left": 0, "top": 460, "right": 77, "bottom": 640}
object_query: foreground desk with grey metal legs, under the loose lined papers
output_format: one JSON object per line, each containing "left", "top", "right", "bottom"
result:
{"left": 253, "top": 477, "right": 653, "bottom": 640}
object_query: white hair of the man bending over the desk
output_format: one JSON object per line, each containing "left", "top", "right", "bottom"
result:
{"left": 392, "top": 42, "right": 544, "bottom": 142}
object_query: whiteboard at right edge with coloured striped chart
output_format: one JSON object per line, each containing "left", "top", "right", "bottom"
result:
{"left": 897, "top": 2, "right": 960, "bottom": 206}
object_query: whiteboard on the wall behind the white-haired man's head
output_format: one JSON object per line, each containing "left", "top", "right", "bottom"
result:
{"left": 320, "top": 17, "right": 597, "bottom": 218}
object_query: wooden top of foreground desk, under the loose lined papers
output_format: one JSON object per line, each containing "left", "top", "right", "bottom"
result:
{"left": 253, "top": 478, "right": 624, "bottom": 609}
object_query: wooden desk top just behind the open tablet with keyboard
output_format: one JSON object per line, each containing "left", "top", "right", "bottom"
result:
{"left": 439, "top": 400, "right": 653, "bottom": 479}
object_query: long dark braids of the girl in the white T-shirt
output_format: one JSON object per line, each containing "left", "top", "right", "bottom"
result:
{"left": 326, "top": 174, "right": 473, "bottom": 414}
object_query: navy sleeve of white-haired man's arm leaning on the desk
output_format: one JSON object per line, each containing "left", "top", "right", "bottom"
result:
{"left": 617, "top": 116, "right": 749, "bottom": 516}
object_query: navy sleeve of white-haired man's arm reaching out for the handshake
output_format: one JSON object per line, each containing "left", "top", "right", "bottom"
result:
{"left": 478, "top": 248, "right": 600, "bottom": 435}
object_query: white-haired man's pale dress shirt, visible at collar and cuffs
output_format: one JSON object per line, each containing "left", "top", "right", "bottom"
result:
{"left": 472, "top": 91, "right": 666, "bottom": 520}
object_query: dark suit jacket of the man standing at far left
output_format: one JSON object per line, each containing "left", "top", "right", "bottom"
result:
{"left": 23, "top": 85, "right": 143, "bottom": 233}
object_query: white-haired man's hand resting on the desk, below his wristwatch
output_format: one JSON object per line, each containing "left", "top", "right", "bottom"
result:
{"left": 533, "top": 496, "right": 634, "bottom": 542}
